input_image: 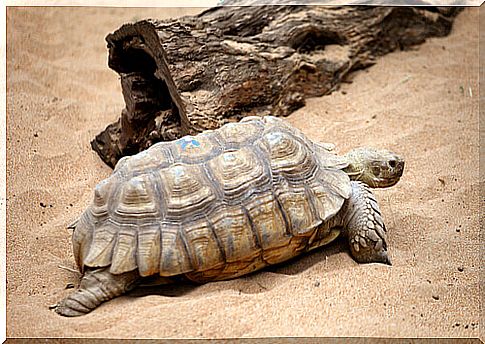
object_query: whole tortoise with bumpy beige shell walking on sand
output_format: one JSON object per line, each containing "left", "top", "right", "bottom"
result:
{"left": 55, "top": 116, "right": 404, "bottom": 316}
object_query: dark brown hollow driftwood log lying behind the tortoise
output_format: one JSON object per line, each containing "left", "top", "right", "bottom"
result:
{"left": 91, "top": 6, "right": 459, "bottom": 167}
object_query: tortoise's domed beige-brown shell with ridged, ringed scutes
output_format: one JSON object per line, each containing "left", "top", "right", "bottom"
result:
{"left": 73, "top": 116, "right": 350, "bottom": 281}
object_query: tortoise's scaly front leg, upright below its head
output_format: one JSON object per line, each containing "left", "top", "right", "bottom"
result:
{"left": 342, "top": 181, "right": 391, "bottom": 265}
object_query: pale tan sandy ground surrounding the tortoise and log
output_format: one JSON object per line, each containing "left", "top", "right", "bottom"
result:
{"left": 7, "top": 8, "right": 480, "bottom": 338}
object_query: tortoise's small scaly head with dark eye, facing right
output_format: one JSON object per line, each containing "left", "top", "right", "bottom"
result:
{"left": 344, "top": 147, "right": 404, "bottom": 188}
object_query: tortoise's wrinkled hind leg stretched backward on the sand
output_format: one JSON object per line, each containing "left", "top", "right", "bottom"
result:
{"left": 55, "top": 267, "right": 140, "bottom": 317}
